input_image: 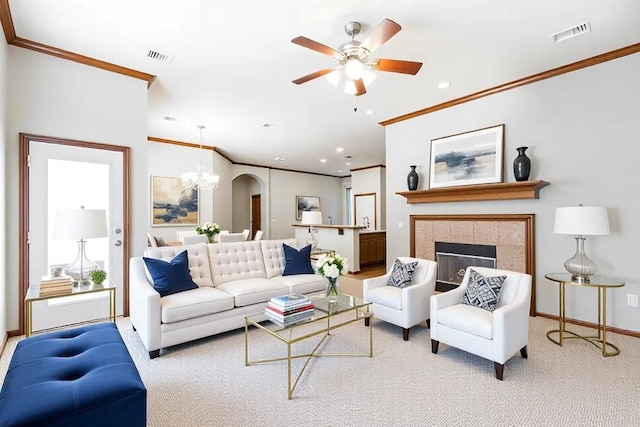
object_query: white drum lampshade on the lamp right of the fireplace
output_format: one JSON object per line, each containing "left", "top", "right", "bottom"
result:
{"left": 553, "top": 206, "right": 609, "bottom": 236}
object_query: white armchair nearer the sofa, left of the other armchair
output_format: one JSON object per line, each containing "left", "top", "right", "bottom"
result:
{"left": 362, "top": 257, "right": 438, "bottom": 341}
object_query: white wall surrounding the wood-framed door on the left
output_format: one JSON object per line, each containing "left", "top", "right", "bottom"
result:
{"left": 0, "top": 46, "right": 149, "bottom": 330}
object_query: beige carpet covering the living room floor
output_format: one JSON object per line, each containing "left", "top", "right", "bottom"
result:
{"left": 0, "top": 310, "right": 640, "bottom": 426}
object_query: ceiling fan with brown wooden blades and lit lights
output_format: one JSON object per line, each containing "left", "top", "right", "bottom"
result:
{"left": 291, "top": 19, "right": 422, "bottom": 96}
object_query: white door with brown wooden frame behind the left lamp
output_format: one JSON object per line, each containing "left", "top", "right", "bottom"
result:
{"left": 20, "top": 135, "right": 129, "bottom": 331}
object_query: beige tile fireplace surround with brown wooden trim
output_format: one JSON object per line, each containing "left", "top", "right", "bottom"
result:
{"left": 409, "top": 214, "right": 536, "bottom": 316}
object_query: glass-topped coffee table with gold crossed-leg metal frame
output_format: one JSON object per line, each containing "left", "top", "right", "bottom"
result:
{"left": 244, "top": 294, "right": 373, "bottom": 399}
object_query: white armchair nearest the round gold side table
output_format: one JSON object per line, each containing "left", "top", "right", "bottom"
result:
{"left": 431, "top": 267, "right": 531, "bottom": 380}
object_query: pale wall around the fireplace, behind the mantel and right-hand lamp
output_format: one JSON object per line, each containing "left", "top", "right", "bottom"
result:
{"left": 386, "top": 54, "right": 640, "bottom": 332}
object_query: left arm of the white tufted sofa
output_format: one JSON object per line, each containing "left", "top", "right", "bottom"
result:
{"left": 129, "top": 257, "right": 162, "bottom": 352}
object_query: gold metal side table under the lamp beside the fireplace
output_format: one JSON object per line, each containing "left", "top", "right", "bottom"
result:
{"left": 544, "top": 273, "right": 624, "bottom": 357}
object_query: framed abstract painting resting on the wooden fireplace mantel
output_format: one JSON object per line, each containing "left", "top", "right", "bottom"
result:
{"left": 429, "top": 125, "right": 504, "bottom": 188}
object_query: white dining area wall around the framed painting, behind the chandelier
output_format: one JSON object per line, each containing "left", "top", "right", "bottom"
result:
{"left": 148, "top": 141, "right": 231, "bottom": 246}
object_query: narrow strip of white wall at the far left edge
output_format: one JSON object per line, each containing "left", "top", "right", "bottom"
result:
{"left": 0, "top": 31, "right": 10, "bottom": 347}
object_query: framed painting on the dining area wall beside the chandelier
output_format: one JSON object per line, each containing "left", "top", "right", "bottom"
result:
{"left": 151, "top": 176, "right": 199, "bottom": 227}
